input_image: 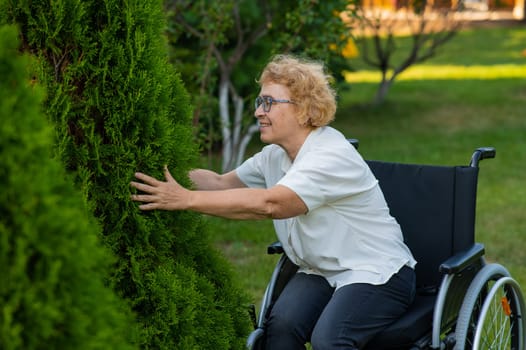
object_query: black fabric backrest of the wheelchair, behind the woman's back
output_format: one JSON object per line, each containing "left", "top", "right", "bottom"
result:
{"left": 367, "top": 161, "right": 479, "bottom": 289}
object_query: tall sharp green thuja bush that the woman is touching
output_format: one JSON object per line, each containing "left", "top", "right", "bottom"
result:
{"left": 0, "top": 0, "right": 249, "bottom": 349}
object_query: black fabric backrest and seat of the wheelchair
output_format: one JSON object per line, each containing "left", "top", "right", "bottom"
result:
{"left": 367, "top": 161, "right": 478, "bottom": 350}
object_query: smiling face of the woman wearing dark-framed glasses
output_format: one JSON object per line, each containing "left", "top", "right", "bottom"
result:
{"left": 254, "top": 83, "right": 310, "bottom": 149}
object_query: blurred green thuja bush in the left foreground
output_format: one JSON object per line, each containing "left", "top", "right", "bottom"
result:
{"left": 0, "top": 26, "right": 137, "bottom": 350}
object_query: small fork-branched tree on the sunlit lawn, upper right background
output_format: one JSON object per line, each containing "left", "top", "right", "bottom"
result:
{"left": 349, "top": 0, "right": 461, "bottom": 105}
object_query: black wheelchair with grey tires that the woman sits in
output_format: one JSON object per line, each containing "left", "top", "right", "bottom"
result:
{"left": 247, "top": 139, "right": 526, "bottom": 350}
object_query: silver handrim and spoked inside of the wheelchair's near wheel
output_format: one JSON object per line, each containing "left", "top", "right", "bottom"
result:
{"left": 473, "top": 277, "right": 526, "bottom": 350}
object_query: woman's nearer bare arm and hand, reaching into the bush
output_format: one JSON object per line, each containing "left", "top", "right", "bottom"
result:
{"left": 131, "top": 168, "right": 308, "bottom": 219}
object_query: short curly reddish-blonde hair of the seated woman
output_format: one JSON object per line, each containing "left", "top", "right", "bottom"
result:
{"left": 257, "top": 55, "right": 336, "bottom": 128}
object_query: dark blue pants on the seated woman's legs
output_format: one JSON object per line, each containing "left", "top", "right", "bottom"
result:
{"left": 266, "top": 267, "right": 415, "bottom": 350}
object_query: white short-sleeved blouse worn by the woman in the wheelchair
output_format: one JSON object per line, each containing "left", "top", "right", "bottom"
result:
{"left": 236, "top": 126, "right": 416, "bottom": 288}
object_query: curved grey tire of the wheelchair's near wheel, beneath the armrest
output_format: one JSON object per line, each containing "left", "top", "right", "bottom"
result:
{"left": 454, "top": 264, "right": 510, "bottom": 350}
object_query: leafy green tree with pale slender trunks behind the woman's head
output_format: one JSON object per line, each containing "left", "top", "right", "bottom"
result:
{"left": 165, "top": 0, "right": 356, "bottom": 171}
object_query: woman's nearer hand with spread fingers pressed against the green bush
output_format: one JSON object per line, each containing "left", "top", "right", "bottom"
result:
{"left": 130, "top": 166, "right": 190, "bottom": 210}
